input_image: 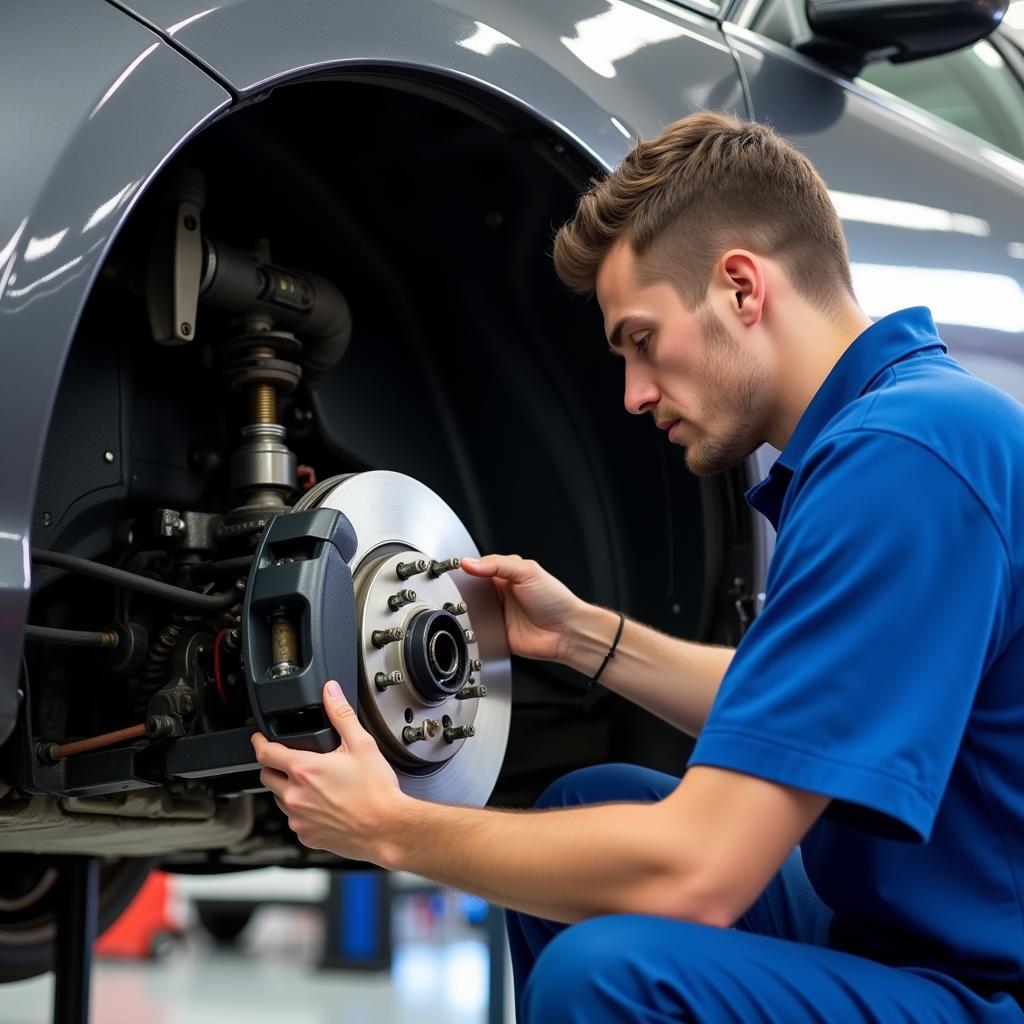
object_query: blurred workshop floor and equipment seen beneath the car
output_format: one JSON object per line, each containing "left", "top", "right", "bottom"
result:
{"left": 0, "top": 867, "right": 514, "bottom": 1024}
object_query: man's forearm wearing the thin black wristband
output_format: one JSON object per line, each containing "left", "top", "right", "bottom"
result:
{"left": 569, "top": 605, "right": 735, "bottom": 736}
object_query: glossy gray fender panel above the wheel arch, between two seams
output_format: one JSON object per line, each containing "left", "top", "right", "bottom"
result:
{"left": 112, "top": 0, "right": 745, "bottom": 158}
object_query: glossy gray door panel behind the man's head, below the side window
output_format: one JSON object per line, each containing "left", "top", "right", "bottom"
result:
{"left": 726, "top": 28, "right": 1024, "bottom": 400}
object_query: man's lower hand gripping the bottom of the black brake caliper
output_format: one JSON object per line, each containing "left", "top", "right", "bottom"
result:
{"left": 253, "top": 680, "right": 403, "bottom": 863}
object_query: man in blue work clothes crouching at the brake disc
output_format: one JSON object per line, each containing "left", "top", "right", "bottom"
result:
{"left": 254, "top": 113, "right": 1024, "bottom": 1024}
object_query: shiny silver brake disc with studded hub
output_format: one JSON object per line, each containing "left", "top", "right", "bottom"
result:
{"left": 293, "top": 470, "right": 512, "bottom": 806}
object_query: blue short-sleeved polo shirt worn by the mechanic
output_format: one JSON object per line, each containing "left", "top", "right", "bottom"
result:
{"left": 690, "top": 308, "right": 1024, "bottom": 988}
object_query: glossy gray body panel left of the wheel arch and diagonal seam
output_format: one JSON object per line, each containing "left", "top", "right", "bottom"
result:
{"left": 0, "top": 0, "right": 230, "bottom": 741}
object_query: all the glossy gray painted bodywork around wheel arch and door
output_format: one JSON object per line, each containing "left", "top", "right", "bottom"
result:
{"left": 0, "top": 0, "right": 1024, "bottom": 739}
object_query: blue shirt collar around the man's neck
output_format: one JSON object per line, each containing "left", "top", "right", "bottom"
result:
{"left": 746, "top": 306, "right": 946, "bottom": 529}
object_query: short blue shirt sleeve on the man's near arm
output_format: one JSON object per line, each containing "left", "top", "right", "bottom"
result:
{"left": 690, "top": 430, "right": 1011, "bottom": 841}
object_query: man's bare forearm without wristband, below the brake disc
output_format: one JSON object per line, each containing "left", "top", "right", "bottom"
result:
{"left": 377, "top": 798, "right": 699, "bottom": 923}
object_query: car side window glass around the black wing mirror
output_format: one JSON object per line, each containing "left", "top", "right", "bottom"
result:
{"left": 752, "top": 0, "right": 1024, "bottom": 160}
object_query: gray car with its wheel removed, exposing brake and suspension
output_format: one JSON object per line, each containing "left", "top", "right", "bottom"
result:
{"left": 0, "top": 0, "right": 1024, "bottom": 980}
